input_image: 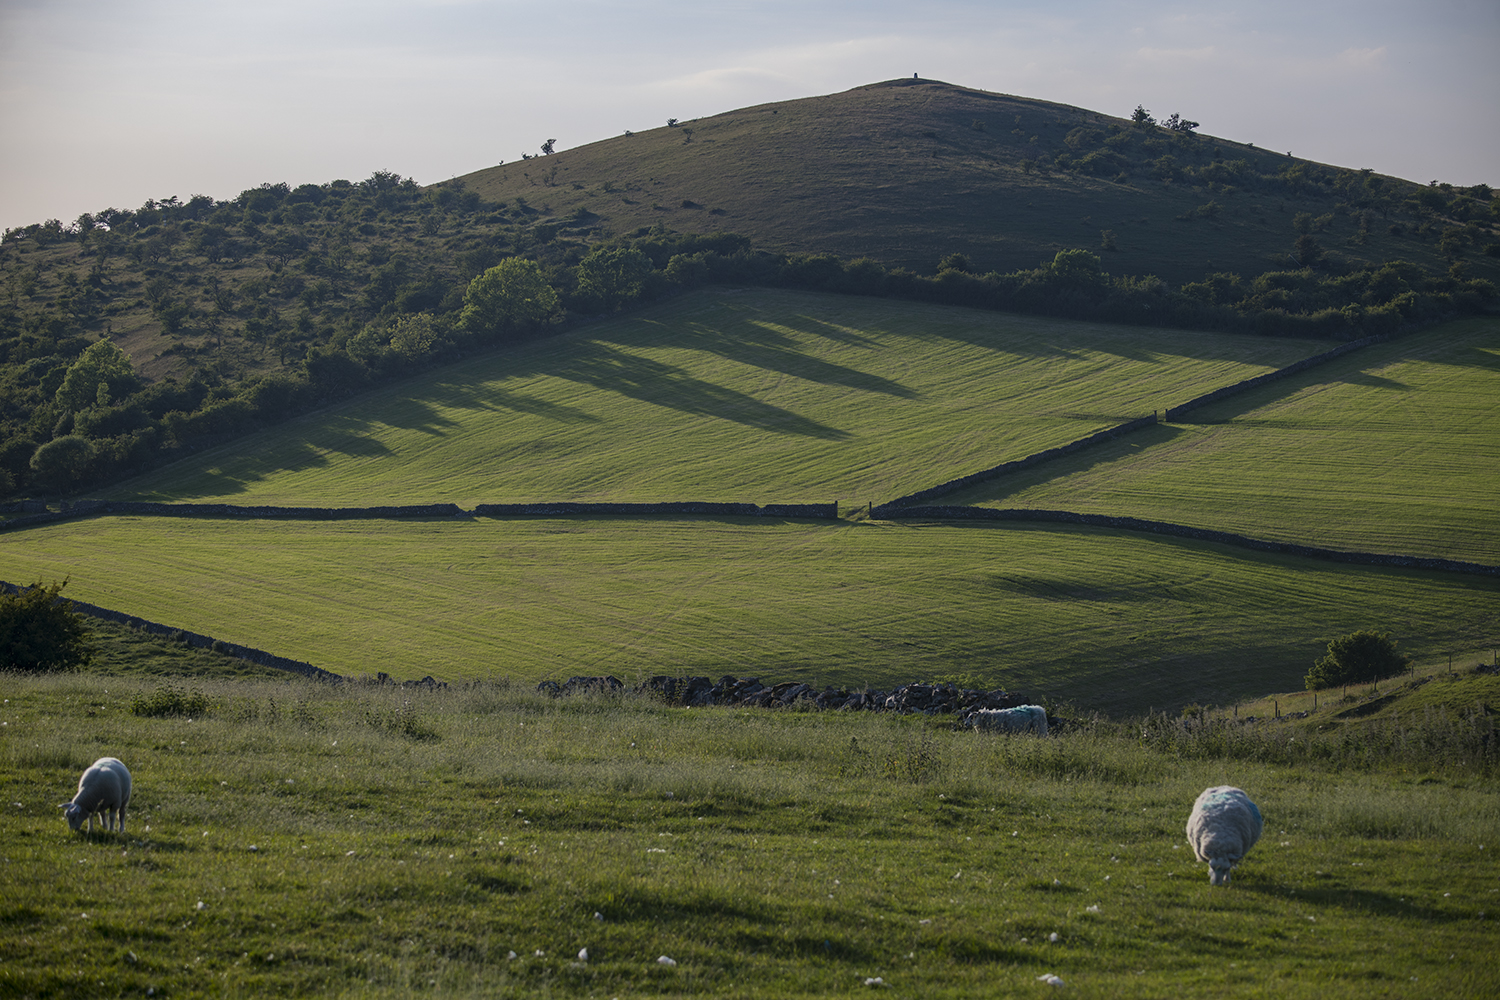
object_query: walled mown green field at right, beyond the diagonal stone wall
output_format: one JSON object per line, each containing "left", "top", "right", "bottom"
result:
{"left": 942, "top": 318, "right": 1500, "bottom": 564}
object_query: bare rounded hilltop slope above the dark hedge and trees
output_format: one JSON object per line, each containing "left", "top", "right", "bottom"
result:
{"left": 462, "top": 79, "right": 1500, "bottom": 283}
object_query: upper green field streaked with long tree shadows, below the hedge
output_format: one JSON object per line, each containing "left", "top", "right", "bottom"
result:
{"left": 108, "top": 289, "right": 1329, "bottom": 507}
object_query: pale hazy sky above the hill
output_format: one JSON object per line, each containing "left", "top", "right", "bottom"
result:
{"left": 0, "top": 0, "right": 1500, "bottom": 228}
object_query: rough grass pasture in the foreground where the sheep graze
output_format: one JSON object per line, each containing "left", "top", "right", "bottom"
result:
{"left": 0, "top": 676, "right": 1500, "bottom": 997}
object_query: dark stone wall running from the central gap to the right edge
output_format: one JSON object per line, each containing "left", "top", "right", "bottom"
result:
{"left": 879, "top": 507, "right": 1500, "bottom": 576}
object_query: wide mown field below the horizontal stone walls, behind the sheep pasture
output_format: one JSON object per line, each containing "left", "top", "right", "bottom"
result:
{"left": 0, "top": 517, "right": 1500, "bottom": 712}
